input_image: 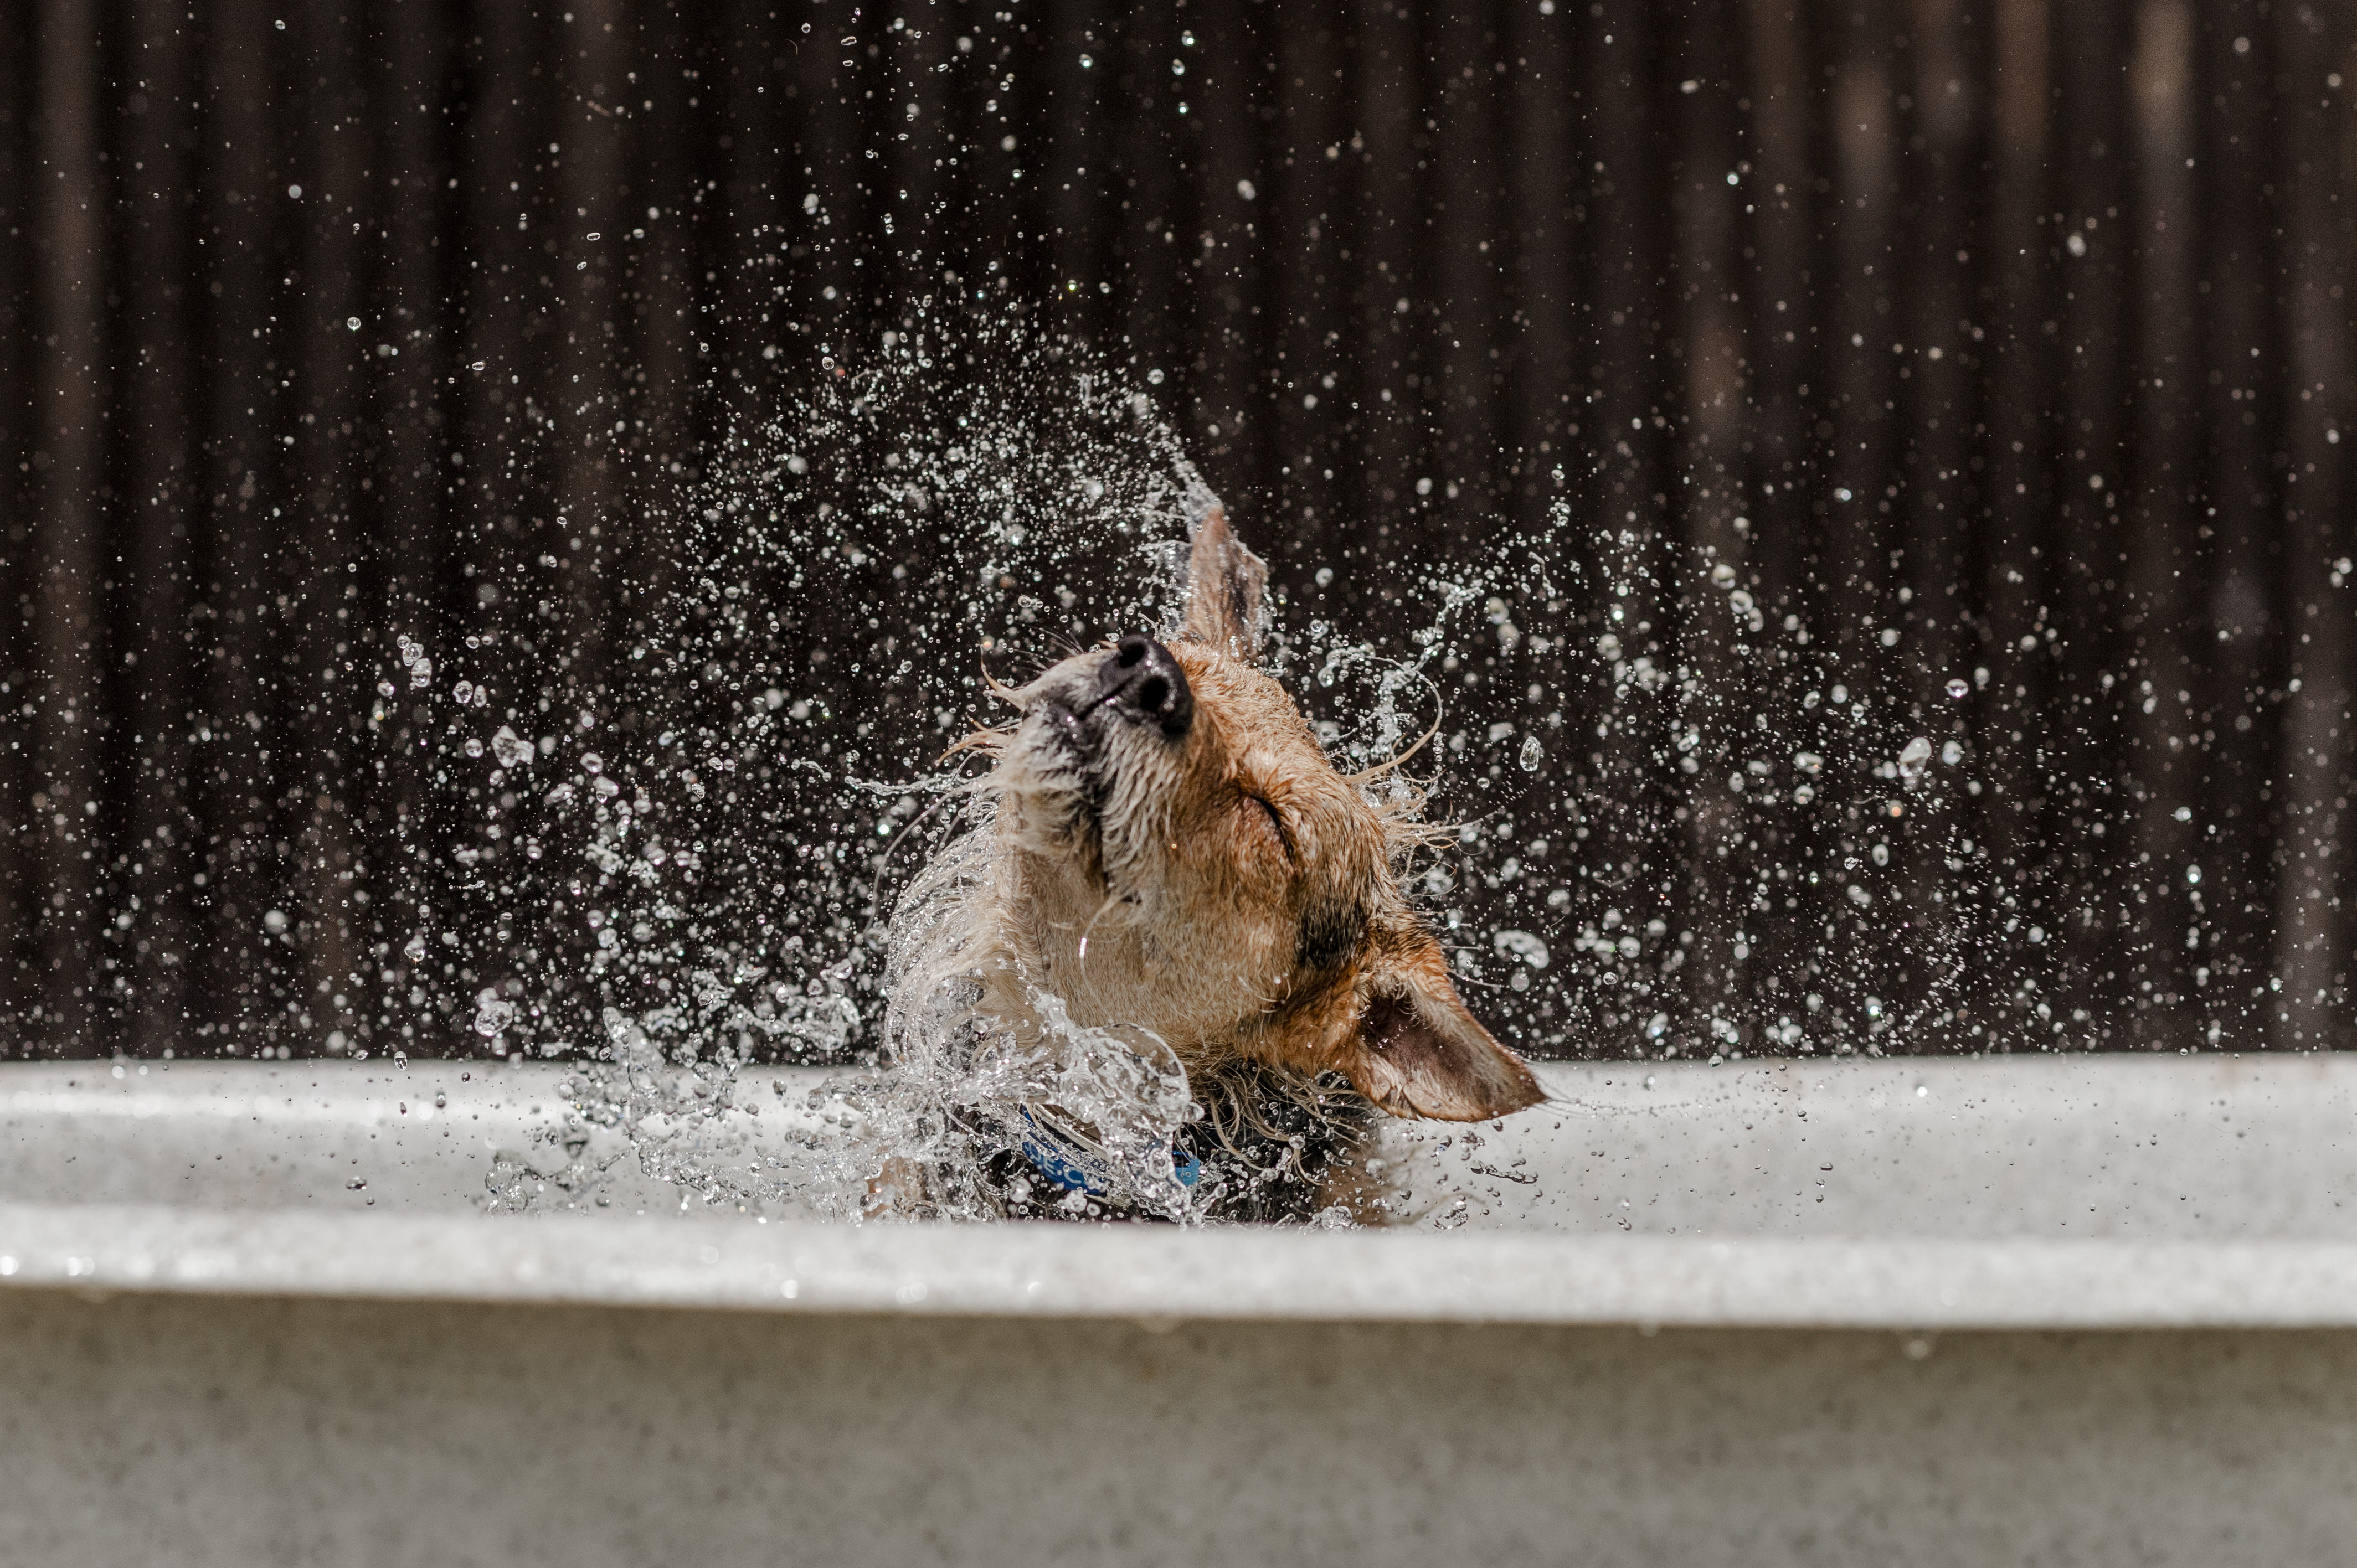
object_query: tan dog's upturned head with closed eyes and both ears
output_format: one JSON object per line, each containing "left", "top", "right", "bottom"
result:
{"left": 990, "top": 504, "right": 1541, "bottom": 1120}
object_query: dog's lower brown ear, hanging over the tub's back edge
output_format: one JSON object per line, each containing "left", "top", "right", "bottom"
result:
{"left": 1341, "top": 927, "right": 1546, "bottom": 1122}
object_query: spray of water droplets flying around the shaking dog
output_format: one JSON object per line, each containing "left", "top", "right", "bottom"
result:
{"left": 353, "top": 309, "right": 2159, "bottom": 1216}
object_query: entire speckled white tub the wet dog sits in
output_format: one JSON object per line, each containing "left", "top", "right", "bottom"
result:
{"left": 14, "top": 1059, "right": 2357, "bottom": 1568}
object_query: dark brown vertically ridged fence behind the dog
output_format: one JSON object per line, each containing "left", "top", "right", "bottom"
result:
{"left": 0, "top": 0, "right": 2357, "bottom": 1054}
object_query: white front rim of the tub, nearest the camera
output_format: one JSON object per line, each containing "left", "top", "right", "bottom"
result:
{"left": 14, "top": 1205, "right": 2357, "bottom": 1330}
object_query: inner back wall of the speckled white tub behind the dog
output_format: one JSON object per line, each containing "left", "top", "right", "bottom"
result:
{"left": 18, "top": 1056, "right": 2357, "bottom": 1242}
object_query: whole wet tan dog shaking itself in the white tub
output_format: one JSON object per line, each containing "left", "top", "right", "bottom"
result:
{"left": 877, "top": 495, "right": 1541, "bottom": 1219}
